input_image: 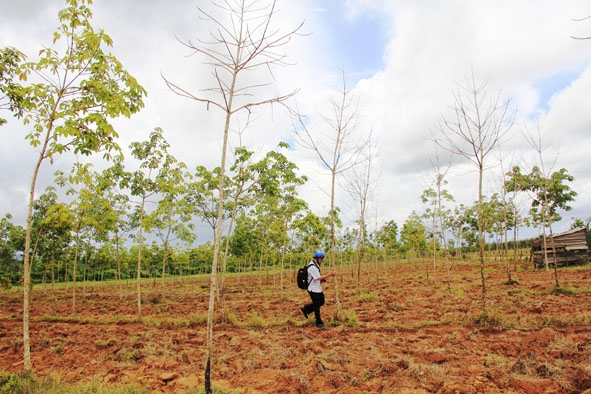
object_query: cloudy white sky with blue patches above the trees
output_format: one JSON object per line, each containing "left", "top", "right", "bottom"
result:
{"left": 0, "top": 0, "right": 591, "bottom": 240}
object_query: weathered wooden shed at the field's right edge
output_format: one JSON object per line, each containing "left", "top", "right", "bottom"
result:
{"left": 531, "top": 227, "right": 589, "bottom": 267}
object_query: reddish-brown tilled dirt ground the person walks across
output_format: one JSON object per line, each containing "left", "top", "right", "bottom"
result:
{"left": 0, "top": 261, "right": 591, "bottom": 394}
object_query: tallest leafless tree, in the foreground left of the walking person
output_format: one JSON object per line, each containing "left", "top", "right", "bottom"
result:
{"left": 164, "top": 0, "right": 303, "bottom": 394}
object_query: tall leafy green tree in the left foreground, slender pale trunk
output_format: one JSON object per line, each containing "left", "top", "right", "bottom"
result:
{"left": 0, "top": 0, "right": 146, "bottom": 371}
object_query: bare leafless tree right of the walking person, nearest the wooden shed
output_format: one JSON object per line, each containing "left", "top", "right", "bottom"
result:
{"left": 435, "top": 72, "right": 515, "bottom": 321}
